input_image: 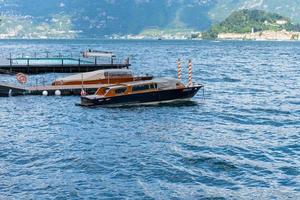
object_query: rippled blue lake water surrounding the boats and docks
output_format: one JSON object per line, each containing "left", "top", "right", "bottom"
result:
{"left": 0, "top": 40, "right": 300, "bottom": 199}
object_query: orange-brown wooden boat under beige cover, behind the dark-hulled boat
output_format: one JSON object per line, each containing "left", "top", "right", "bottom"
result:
{"left": 52, "top": 69, "right": 153, "bottom": 85}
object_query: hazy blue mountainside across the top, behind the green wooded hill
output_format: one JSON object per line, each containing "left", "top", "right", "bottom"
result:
{"left": 0, "top": 0, "right": 300, "bottom": 38}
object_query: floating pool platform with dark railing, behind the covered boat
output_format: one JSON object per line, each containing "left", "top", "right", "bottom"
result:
{"left": 0, "top": 52, "right": 131, "bottom": 74}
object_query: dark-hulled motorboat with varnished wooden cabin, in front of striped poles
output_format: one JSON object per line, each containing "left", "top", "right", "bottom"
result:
{"left": 78, "top": 78, "right": 203, "bottom": 106}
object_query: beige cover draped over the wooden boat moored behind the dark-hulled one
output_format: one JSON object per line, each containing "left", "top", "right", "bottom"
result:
{"left": 55, "top": 69, "right": 133, "bottom": 83}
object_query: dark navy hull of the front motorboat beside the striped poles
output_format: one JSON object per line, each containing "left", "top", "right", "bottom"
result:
{"left": 78, "top": 86, "right": 203, "bottom": 107}
